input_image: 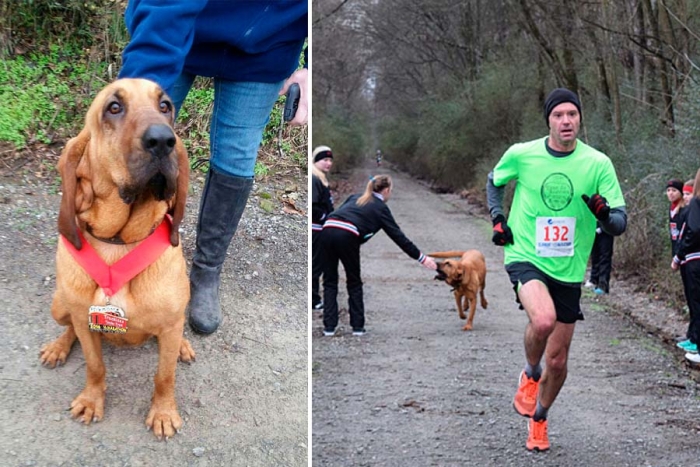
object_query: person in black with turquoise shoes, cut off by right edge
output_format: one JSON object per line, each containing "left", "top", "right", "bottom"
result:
{"left": 671, "top": 174, "right": 700, "bottom": 363}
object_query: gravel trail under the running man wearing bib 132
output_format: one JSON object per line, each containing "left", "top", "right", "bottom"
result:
{"left": 312, "top": 163, "right": 700, "bottom": 466}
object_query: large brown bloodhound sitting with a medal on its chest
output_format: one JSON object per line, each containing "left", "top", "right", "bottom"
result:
{"left": 40, "top": 79, "right": 195, "bottom": 439}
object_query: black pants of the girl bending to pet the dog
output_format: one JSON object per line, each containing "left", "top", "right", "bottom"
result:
{"left": 321, "top": 228, "right": 365, "bottom": 330}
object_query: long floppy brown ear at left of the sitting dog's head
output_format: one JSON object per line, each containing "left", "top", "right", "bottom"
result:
{"left": 58, "top": 130, "right": 90, "bottom": 250}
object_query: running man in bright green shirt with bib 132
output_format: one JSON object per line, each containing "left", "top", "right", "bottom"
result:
{"left": 486, "top": 88, "right": 627, "bottom": 451}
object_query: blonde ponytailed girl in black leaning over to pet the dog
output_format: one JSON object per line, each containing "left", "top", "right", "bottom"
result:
{"left": 321, "top": 175, "right": 437, "bottom": 336}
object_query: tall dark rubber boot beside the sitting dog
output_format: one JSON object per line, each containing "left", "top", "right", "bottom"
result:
{"left": 189, "top": 169, "right": 253, "bottom": 334}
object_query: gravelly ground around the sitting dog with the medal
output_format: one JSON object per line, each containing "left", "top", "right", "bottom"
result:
{"left": 0, "top": 171, "right": 308, "bottom": 467}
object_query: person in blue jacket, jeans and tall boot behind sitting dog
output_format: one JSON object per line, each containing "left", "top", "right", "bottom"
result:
{"left": 119, "top": 0, "right": 308, "bottom": 334}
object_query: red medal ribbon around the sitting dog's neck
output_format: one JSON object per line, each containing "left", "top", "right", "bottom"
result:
{"left": 61, "top": 216, "right": 172, "bottom": 297}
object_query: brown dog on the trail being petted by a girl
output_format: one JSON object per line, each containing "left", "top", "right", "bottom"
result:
{"left": 428, "top": 250, "right": 489, "bottom": 331}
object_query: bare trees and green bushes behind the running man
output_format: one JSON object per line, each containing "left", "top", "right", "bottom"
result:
{"left": 312, "top": 0, "right": 700, "bottom": 310}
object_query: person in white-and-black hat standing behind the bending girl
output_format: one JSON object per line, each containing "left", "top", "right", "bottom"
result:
{"left": 311, "top": 146, "right": 333, "bottom": 310}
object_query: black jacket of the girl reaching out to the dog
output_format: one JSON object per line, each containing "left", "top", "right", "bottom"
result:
{"left": 329, "top": 195, "right": 422, "bottom": 260}
